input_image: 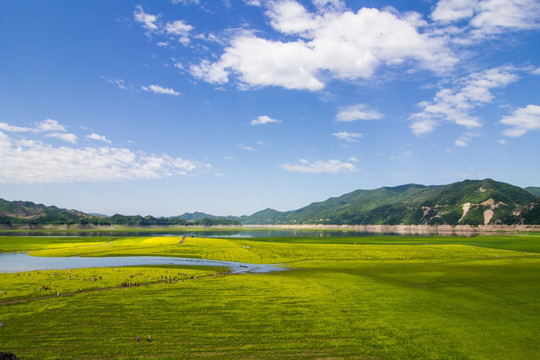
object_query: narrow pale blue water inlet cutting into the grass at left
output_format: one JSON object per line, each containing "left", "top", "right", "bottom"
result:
{"left": 0, "top": 253, "right": 285, "bottom": 273}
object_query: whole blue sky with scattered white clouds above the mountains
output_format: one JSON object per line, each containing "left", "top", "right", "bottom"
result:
{"left": 0, "top": 0, "right": 540, "bottom": 216}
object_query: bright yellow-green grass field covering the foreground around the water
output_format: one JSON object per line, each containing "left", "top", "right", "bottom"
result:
{"left": 0, "top": 235, "right": 540, "bottom": 359}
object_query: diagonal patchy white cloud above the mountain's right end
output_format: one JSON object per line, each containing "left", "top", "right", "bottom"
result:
{"left": 409, "top": 66, "right": 518, "bottom": 135}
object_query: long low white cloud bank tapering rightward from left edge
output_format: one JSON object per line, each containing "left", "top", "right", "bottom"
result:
{"left": 0, "top": 132, "right": 201, "bottom": 183}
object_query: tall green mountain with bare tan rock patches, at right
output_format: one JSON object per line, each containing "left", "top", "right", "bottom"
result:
{"left": 240, "top": 179, "right": 538, "bottom": 225}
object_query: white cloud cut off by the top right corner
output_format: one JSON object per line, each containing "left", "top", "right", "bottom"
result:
{"left": 431, "top": 0, "right": 540, "bottom": 37}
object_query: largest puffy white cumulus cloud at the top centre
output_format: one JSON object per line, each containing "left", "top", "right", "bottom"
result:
{"left": 190, "top": 0, "right": 457, "bottom": 91}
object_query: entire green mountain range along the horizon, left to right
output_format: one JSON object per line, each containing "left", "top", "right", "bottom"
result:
{"left": 0, "top": 179, "right": 540, "bottom": 226}
